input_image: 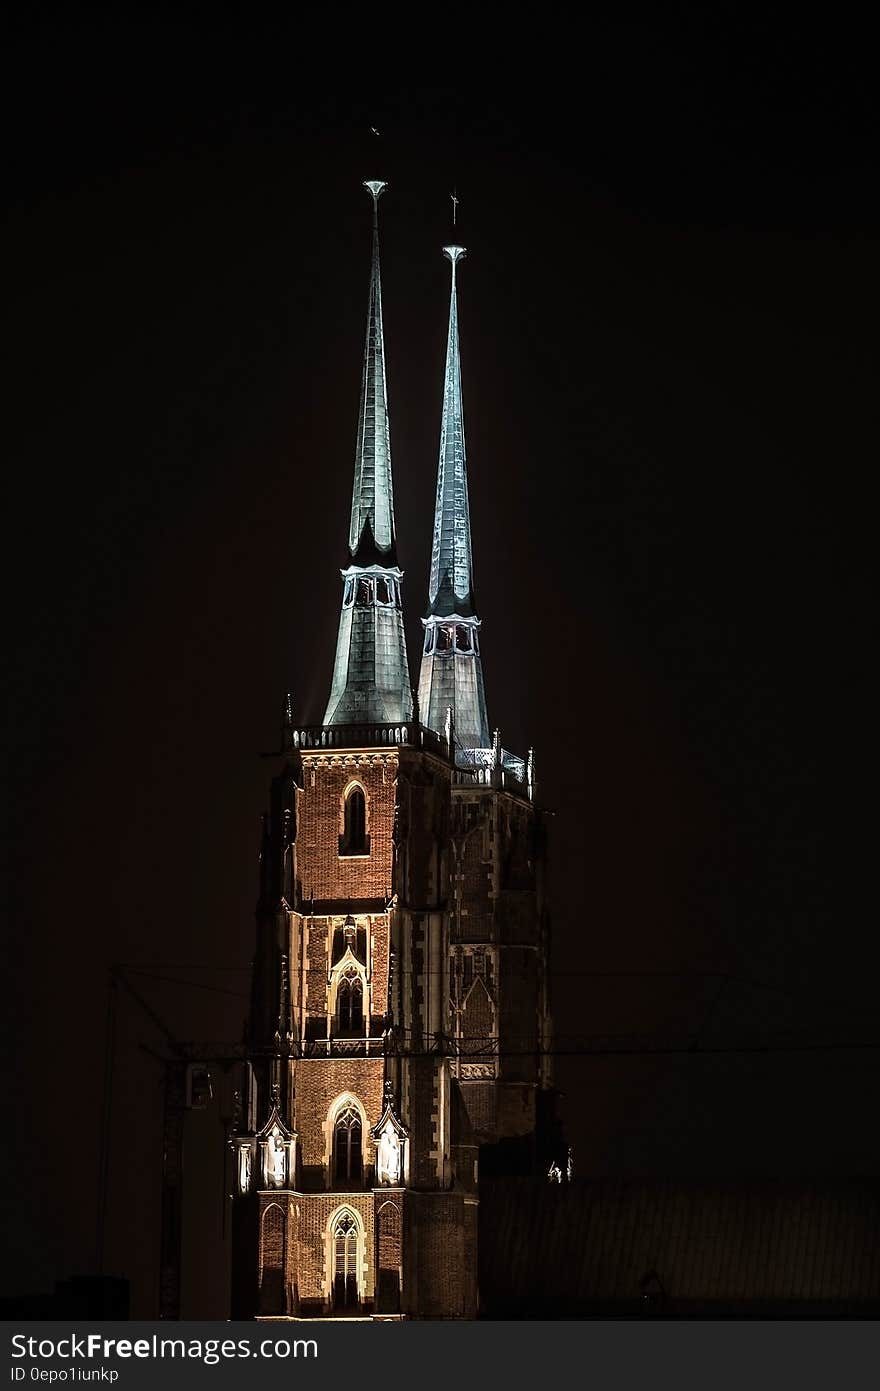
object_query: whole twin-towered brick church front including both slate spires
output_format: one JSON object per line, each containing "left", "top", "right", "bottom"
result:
{"left": 231, "top": 182, "right": 549, "bottom": 1319}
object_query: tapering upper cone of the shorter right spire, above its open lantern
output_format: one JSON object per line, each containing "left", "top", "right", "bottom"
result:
{"left": 428, "top": 246, "right": 474, "bottom": 616}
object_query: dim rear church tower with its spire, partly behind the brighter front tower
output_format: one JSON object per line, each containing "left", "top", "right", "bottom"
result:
{"left": 418, "top": 245, "right": 553, "bottom": 1171}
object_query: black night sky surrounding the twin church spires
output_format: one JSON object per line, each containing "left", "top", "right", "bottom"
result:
{"left": 3, "top": 8, "right": 880, "bottom": 1313}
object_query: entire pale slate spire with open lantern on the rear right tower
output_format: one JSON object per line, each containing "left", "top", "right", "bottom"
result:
{"left": 418, "top": 246, "right": 489, "bottom": 751}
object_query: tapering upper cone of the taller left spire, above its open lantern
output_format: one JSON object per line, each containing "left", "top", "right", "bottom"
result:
{"left": 349, "top": 179, "right": 395, "bottom": 565}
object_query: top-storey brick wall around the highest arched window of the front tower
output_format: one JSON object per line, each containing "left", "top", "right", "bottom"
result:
{"left": 296, "top": 751, "right": 398, "bottom": 903}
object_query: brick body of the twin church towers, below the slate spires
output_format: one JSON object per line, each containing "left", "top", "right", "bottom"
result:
{"left": 234, "top": 746, "right": 544, "bottom": 1319}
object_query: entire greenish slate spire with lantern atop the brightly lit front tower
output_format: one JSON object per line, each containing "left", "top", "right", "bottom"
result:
{"left": 324, "top": 179, "right": 413, "bottom": 725}
